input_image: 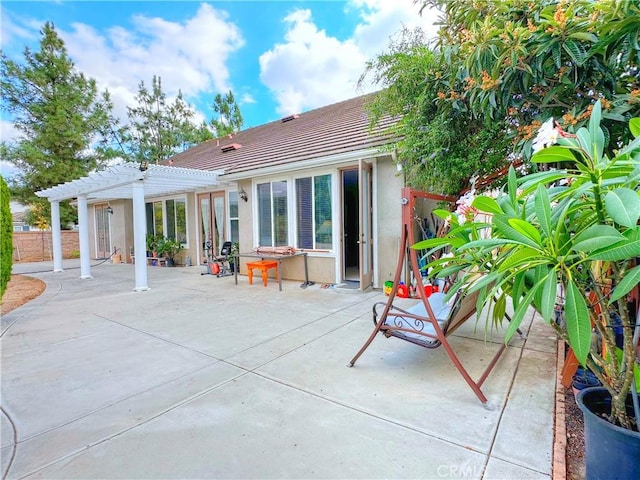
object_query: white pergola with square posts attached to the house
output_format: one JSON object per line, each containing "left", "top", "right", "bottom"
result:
{"left": 36, "top": 164, "right": 223, "bottom": 291}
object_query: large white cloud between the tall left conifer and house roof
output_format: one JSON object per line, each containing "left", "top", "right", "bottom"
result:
{"left": 59, "top": 4, "right": 244, "bottom": 124}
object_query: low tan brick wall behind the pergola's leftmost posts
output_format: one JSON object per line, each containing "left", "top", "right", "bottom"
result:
{"left": 13, "top": 230, "right": 80, "bottom": 262}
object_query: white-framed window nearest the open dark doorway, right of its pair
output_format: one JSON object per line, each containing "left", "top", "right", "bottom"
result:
{"left": 296, "top": 175, "right": 333, "bottom": 250}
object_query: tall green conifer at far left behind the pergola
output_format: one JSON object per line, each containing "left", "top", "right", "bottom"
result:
{"left": 0, "top": 23, "right": 113, "bottom": 228}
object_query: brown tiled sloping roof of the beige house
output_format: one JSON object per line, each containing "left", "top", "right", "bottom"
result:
{"left": 167, "top": 94, "right": 395, "bottom": 174}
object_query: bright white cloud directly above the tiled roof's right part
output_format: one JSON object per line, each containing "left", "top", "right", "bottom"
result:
{"left": 260, "top": 0, "right": 437, "bottom": 115}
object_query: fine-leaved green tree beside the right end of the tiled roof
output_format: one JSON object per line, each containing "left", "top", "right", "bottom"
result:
{"left": 360, "top": 28, "right": 509, "bottom": 194}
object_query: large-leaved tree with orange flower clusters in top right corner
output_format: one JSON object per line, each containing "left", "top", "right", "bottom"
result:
{"left": 417, "top": 0, "right": 640, "bottom": 156}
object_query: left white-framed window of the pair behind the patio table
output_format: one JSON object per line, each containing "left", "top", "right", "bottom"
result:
{"left": 257, "top": 180, "right": 289, "bottom": 247}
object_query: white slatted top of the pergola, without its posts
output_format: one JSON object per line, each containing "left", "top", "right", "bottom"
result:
{"left": 36, "top": 163, "right": 221, "bottom": 201}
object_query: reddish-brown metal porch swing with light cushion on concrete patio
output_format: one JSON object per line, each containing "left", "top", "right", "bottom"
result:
{"left": 348, "top": 187, "right": 523, "bottom": 410}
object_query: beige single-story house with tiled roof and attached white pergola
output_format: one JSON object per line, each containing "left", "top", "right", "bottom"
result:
{"left": 38, "top": 94, "right": 412, "bottom": 290}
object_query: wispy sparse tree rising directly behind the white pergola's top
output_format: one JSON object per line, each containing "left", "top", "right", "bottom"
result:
{"left": 121, "top": 75, "right": 213, "bottom": 163}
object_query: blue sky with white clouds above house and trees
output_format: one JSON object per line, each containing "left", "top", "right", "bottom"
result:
{"left": 0, "top": 0, "right": 437, "bottom": 150}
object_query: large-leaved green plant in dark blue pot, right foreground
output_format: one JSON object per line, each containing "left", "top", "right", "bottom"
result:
{"left": 414, "top": 102, "right": 640, "bottom": 478}
